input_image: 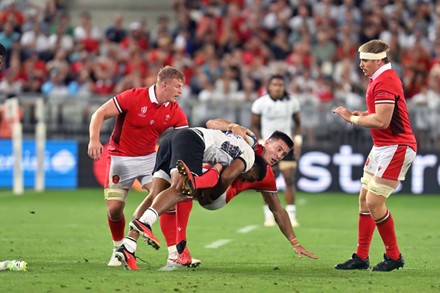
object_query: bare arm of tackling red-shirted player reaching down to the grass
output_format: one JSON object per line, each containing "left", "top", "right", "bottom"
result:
{"left": 261, "top": 192, "right": 318, "bottom": 259}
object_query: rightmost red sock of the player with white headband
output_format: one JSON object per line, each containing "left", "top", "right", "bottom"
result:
{"left": 376, "top": 210, "right": 400, "bottom": 260}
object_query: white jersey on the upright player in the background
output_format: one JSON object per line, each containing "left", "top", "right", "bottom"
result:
{"left": 251, "top": 94, "right": 300, "bottom": 140}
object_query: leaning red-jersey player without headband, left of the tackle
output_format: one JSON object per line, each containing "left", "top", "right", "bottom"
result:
{"left": 88, "top": 66, "right": 188, "bottom": 266}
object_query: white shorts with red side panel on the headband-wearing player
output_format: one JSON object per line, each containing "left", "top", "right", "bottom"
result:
{"left": 364, "top": 145, "right": 416, "bottom": 181}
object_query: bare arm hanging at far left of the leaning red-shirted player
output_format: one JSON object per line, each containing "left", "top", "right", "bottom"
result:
{"left": 87, "top": 99, "right": 119, "bottom": 160}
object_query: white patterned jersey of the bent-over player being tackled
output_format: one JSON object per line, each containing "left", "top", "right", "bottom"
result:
{"left": 190, "top": 127, "right": 255, "bottom": 173}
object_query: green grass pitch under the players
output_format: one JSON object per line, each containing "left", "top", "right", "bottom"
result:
{"left": 0, "top": 189, "right": 440, "bottom": 293}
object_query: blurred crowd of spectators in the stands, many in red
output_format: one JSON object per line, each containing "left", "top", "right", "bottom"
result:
{"left": 0, "top": 0, "right": 440, "bottom": 149}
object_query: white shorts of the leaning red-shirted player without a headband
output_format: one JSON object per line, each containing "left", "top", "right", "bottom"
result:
{"left": 104, "top": 153, "right": 156, "bottom": 190}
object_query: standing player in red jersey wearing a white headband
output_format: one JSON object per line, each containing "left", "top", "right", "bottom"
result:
{"left": 332, "top": 40, "right": 417, "bottom": 272}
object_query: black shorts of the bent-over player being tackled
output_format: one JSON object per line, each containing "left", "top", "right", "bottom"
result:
{"left": 153, "top": 128, "right": 205, "bottom": 175}
